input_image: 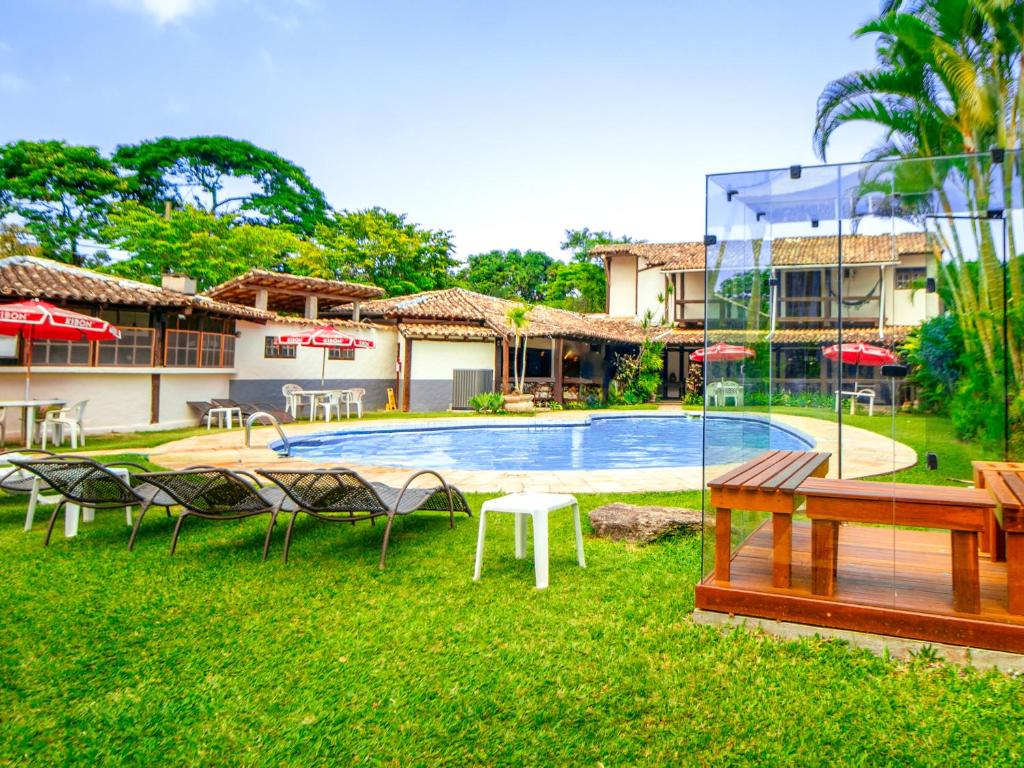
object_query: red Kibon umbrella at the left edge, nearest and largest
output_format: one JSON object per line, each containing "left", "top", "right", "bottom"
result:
{"left": 0, "top": 299, "right": 121, "bottom": 399}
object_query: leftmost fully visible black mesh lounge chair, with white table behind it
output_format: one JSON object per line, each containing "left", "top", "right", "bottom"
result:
{"left": 10, "top": 456, "right": 176, "bottom": 549}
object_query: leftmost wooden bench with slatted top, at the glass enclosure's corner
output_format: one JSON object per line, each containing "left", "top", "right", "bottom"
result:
{"left": 708, "top": 451, "right": 831, "bottom": 588}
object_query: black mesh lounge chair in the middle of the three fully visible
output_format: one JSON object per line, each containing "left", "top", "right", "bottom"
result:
{"left": 132, "top": 467, "right": 294, "bottom": 560}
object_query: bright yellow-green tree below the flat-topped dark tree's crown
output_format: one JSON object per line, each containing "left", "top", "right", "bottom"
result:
{"left": 102, "top": 201, "right": 316, "bottom": 290}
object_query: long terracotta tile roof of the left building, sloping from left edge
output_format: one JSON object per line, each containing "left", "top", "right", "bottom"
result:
{"left": 0, "top": 256, "right": 270, "bottom": 321}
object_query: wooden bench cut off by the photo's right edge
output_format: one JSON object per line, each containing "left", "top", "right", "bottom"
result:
{"left": 971, "top": 462, "right": 1024, "bottom": 614}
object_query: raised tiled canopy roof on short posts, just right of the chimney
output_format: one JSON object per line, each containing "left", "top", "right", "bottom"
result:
{"left": 204, "top": 269, "right": 384, "bottom": 312}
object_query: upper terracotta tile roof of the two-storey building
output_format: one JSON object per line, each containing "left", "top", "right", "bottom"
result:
{"left": 592, "top": 232, "right": 929, "bottom": 272}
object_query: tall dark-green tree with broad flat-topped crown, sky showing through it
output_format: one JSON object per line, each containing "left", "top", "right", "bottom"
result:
{"left": 114, "top": 136, "right": 328, "bottom": 234}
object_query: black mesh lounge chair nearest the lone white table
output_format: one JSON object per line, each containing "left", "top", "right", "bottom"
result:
{"left": 256, "top": 467, "right": 472, "bottom": 570}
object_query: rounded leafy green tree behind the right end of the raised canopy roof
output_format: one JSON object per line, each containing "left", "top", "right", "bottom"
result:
{"left": 290, "top": 208, "right": 457, "bottom": 296}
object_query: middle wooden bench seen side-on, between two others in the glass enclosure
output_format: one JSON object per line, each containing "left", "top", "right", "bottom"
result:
{"left": 798, "top": 478, "right": 993, "bottom": 613}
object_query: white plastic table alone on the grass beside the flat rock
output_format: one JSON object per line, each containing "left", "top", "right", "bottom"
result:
{"left": 473, "top": 493, "right": 587, "bottom": 590}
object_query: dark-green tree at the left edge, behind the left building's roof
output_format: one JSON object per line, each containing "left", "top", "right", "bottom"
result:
{"left": 0, "top": 141, "right": 125, "bottom": 266}
